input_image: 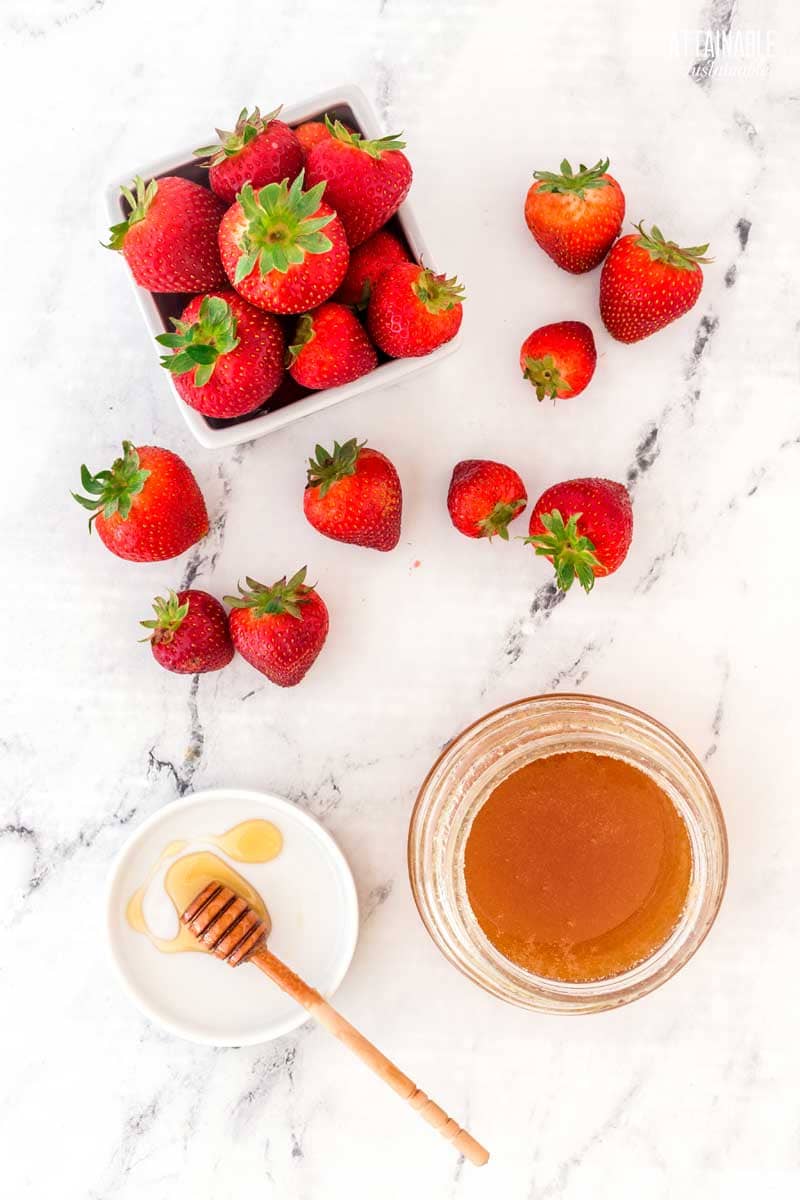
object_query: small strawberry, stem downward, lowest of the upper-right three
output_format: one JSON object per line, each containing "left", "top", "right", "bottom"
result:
{"left": 519, "top": 320, "right": 597, "bottom": 400}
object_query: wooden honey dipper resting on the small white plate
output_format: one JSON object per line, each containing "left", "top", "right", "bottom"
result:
{"left": 181, "top": 882, "right": 489, "bottom": 1166}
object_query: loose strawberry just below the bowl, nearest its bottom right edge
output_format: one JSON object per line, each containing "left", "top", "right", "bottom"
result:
{"left": 302, "top": 438, "right": 403, "bottom": 550}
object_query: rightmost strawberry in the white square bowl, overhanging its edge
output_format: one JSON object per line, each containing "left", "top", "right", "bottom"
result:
{"left": 367, "top": 263, "right": 464, "bottom": 359}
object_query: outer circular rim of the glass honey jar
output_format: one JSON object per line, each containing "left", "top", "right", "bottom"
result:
{"left": 407, "top": 691, "right": 730, "bottom": 1016}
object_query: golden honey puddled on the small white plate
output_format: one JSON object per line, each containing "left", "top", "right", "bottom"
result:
{"left": 125, "top": 818, "right": 283, "bottom": 954}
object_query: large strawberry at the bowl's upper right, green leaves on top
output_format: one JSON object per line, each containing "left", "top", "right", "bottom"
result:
{"left": 306, "top": 116, "right": 411, "bottom": 246}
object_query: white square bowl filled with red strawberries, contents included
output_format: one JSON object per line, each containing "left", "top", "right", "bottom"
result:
{"left": 107, "top": 86, "right": 463, "bottom": 449}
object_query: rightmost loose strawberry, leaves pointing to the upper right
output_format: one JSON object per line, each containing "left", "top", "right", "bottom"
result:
{"left": 600, "top": 223, "right": 712, "bottom": 342}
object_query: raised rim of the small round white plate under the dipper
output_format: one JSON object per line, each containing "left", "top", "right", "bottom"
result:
{"left": 104, "top": 786, "right": 360, "bottom": 1046}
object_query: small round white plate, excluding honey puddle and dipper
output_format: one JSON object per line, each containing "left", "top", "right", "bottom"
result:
{"left": 107, "top": 788, "right": 359, "bottom": 1046}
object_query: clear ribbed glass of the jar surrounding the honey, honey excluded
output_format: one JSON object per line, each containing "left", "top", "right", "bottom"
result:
{"left": 408, "top": 694, "right": 728, "bottom": 1013}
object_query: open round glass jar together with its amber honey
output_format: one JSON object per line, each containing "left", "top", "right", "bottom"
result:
{"left": 409, "top": 695, "right": 728, "bottom": 1013}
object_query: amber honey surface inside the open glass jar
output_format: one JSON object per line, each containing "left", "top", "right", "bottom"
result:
{"left": 464, "top": 751, "right": 692, "bottom": 983}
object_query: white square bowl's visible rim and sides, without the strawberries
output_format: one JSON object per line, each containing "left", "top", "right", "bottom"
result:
{"left": 106, "top": 84, "right": 461, "bottom": 450}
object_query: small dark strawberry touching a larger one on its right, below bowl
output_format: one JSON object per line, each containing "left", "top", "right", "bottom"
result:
{"left": 139, "top": 588, "right": 234, "bottom": 674}
